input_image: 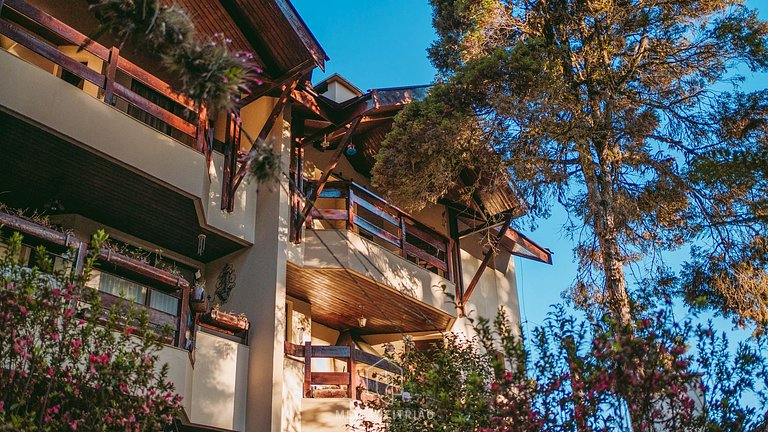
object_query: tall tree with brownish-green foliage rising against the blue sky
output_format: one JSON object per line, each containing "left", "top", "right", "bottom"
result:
{"left": 373, "top": 0, "right": 768, "bottom": 327}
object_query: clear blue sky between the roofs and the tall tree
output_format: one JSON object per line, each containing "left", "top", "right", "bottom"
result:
{"left": 292, "top": 0, "right": 768, "bottom": 333}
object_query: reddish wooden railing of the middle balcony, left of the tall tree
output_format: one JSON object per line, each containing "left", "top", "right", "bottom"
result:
{"left": 305, "top": 182, "right": 456, "bottom": 281}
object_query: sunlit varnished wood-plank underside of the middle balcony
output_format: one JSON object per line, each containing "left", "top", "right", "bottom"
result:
{"left": 286, "top": 262, "right": 455, "bottom": 335}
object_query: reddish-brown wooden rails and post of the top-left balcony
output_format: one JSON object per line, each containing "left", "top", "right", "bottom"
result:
{"left": 0, "top": 0, "right": 208, "bottom": 145}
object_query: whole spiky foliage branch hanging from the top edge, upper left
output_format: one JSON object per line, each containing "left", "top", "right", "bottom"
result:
{"left": 90, "top": 0, "right": 261, "bottom": 113}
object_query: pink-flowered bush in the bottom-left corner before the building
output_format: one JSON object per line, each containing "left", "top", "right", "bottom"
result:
{"left": 0, "top": 232, "right": 181, "bottom": 431}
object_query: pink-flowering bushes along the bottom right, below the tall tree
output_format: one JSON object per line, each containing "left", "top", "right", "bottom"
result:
{"left": 379, "top": 309, "right": 768, "bottom": 431}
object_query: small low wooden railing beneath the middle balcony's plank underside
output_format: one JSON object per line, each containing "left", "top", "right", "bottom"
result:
{"left": 285, "top": 342, "right": 403, "bottom": 399}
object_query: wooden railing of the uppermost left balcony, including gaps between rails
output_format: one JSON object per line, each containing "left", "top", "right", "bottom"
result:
{"left": 0, "top": 0, "right": 208, "bottom": 151}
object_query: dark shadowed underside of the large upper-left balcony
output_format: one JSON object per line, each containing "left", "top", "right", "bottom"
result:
{"left": 0, "top": 110, "right": 248, "bottom": 262}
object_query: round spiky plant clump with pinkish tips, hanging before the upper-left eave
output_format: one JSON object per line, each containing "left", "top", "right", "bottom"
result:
{"left": 163, "top": 34, "right": 262, "bottom": 112}
